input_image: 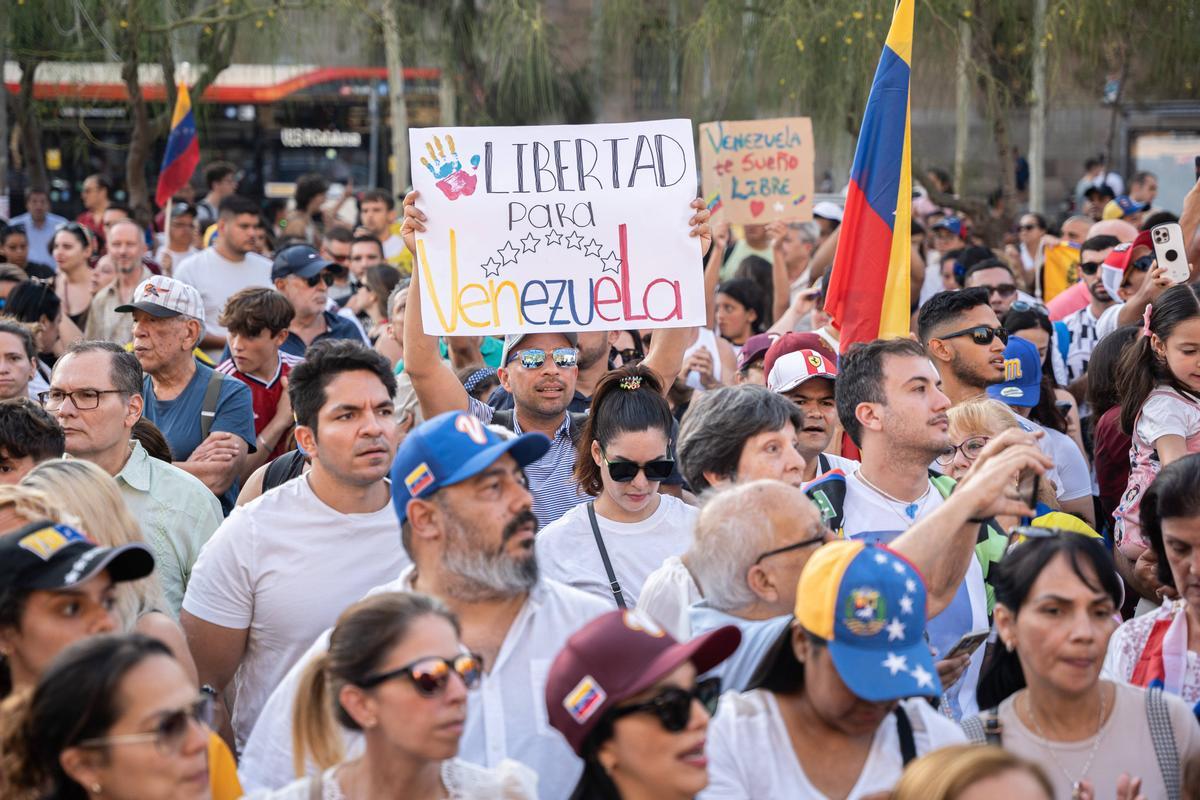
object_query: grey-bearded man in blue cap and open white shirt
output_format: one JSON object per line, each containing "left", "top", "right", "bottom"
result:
{"left": 240, "top": 410, "right": 611, "bottom": 800}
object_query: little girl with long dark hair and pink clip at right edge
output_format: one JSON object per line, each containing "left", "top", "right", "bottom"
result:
{"left": 1112, "top": 284, "right": 1200, "bottom": 585}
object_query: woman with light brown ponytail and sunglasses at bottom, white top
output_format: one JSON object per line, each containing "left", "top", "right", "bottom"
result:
{"left": 254, "top": 593, "right": 538, "bottom": 800}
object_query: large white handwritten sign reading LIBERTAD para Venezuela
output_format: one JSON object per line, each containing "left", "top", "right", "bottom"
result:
{"left": 408, "top": 120, "right": 704, "bottom": 336}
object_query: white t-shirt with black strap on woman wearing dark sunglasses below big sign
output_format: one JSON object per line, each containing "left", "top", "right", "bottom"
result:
{"left": 538, "top": 494, "right": 700, "bottom": 608}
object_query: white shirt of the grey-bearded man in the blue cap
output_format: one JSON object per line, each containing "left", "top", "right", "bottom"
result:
{"left": 238, "top": 568, "right": 610, "bottom": 800}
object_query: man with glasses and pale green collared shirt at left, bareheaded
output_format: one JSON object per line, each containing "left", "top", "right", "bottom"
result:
{"left": 46, "top": 342, "right": 221, "bottom": 616}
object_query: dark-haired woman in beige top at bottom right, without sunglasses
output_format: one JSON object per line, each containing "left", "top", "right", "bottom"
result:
{"left": 962, "top": 529, "right": 1200, "bottom": 800}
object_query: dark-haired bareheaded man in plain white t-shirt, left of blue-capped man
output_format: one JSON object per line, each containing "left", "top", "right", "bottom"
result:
{"left": 180, "top": 339, "right": 409, "bottom": 746}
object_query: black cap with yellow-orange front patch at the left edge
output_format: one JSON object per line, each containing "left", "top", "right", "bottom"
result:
{"left": 0, "top": 519, "right": 154, "bottom": 591}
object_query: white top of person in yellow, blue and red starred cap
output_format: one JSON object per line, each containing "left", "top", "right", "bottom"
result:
{"left": 698, "top": 690, "right": 966, "bottom": 800}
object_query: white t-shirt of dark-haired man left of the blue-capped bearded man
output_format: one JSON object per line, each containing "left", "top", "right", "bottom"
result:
{"left": 184, "top": 476, "right": 409, "bottom": 748}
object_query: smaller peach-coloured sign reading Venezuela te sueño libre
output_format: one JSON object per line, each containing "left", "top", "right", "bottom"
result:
{"left": 700, "top": 116, "right": 814, "bottom": 224}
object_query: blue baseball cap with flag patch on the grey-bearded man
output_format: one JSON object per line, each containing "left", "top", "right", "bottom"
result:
{"left": 391, "top": 411, "right": 550, "bottom": 523}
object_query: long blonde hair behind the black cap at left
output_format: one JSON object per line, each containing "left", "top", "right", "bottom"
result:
{"left": 20, "top": 458, "right": 168, "bottom": 633}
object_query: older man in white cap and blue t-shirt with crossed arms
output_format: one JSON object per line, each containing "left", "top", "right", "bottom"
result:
{"left": 116, "top": 275, "right": 254, "bottom": 513}
